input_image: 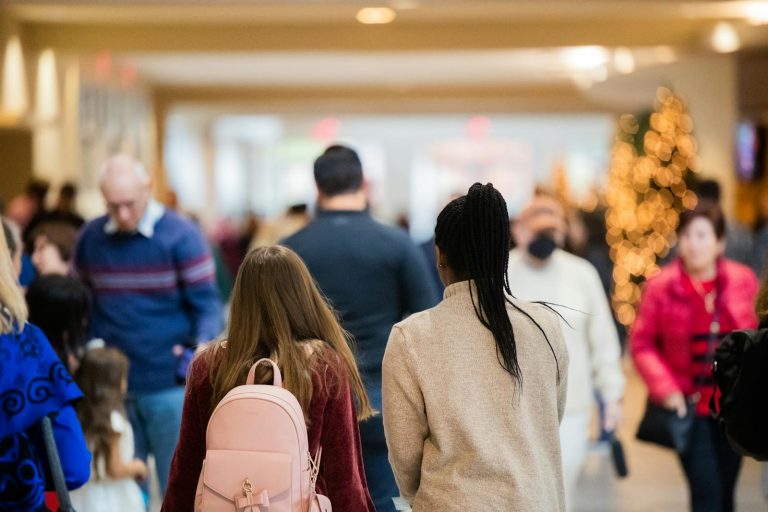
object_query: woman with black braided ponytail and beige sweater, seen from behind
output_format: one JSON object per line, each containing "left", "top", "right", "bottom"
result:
{"left": 383, "top": 183, "right": 568, "bottom": 512}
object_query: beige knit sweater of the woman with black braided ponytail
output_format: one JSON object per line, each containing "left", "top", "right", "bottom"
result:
{"left": 382, "top": 281, "right": 568, "bottom": 512}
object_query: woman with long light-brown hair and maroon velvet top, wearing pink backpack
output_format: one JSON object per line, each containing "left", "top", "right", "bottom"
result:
{"left": 163, "top": 246, "right": 375, "bottom": 512}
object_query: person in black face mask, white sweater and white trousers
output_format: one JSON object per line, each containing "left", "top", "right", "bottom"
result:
{"left": 508, "top": 195, "right": 625, "bottom": 509}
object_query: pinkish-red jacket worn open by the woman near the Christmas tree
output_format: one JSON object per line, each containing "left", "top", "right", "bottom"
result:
{"left": 630, "top": 259, "right": 758, "bottom": 402}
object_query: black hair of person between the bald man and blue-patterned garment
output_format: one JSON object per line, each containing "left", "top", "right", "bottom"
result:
{"left": 27, "top": 275, "right": 91, "bottom": 371}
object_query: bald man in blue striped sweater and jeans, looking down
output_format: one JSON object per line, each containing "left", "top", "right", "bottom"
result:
{"left": 75, "top": 155, "right": 222, "bottom": 492}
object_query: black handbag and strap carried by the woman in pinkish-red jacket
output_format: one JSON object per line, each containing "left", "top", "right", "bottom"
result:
{"left": 635, "top": 312, "right": 720, "bottom": 454}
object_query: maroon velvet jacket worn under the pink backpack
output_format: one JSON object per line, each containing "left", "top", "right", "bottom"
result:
{"left": 162, "top": 349, "right": 376, "bottom": 512}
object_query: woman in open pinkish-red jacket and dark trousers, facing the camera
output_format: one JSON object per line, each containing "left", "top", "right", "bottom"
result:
{"left": 630, "top": 202, "right": 758, "bottom": 512}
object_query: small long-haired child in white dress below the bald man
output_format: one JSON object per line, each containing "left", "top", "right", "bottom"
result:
{"left": 71, "top": 348, "right": 147, "bottom": 512}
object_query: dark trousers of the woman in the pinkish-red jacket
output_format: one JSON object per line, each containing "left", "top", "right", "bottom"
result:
{"left": 680, "top": 417, "right": 741, "bottom": 512}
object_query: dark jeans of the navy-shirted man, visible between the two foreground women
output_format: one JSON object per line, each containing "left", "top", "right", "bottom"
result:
{"left": 360, "top": 415, "right": 400, "bottom": 512}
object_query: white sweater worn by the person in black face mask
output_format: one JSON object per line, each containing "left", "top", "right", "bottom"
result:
{"left": 509, "top": 249, "right": 625, "bottom": 414}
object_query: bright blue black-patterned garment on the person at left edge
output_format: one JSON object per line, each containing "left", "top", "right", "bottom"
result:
{"left": 0, "top": 324, "right": 91, "bottom": 512}
